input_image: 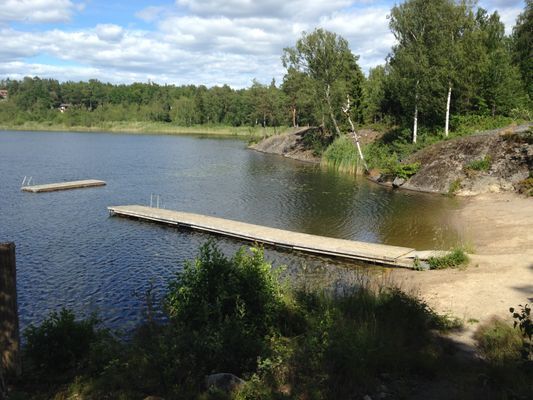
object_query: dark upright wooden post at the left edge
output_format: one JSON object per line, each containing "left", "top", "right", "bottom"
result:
{"left": 0, "top": 242, "right": 22, "bottom": 375}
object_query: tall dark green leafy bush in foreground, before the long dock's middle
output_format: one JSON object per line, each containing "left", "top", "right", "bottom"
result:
{"left": 165, "top": 242, "right": 282, "bottom": 377}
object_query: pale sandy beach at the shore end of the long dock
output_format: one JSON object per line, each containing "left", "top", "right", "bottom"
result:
{"left": 393, "top": 194, "right": 533, "bottom": 341}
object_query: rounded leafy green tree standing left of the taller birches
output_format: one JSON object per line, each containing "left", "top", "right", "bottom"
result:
{"left": 282, "top": 29, "right": 363, "bottom": 136}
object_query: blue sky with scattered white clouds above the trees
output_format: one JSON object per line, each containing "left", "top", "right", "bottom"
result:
{"left": 0, "top": 0, "right": 525, "bottom": 88}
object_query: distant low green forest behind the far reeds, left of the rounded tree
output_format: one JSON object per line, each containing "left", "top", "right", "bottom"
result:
{"left": 0, "top": 78, "right": 289, "bottom": 130}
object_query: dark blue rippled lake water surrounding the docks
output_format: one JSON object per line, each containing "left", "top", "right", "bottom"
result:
{"left": 0, "top": 131, "right": 459, "bottom": 330}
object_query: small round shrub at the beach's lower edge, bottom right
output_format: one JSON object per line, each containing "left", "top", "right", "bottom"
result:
{"left": 474, "top": 318, "right": 522, "bottom": 365}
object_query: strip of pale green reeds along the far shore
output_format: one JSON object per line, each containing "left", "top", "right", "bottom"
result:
{"left": 0, "top": 121, "right": 287, "bottom": 137}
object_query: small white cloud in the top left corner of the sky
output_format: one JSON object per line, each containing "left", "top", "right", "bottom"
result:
{"left": 0, "top": 0, "right": 79, "bottom": 23}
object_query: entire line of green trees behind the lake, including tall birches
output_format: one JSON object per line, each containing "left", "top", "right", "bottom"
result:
{"left": 0, "top": 0, "right": 533, "bottom": 142}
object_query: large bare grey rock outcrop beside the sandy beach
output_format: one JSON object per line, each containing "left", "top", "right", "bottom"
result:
{"left": 402, "top": 124, "right": 533, "bottom": 196}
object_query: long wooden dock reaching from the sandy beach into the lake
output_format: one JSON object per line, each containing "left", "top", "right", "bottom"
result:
{"left": 108, "top": 205, "right": 446, "bottom": 268}
